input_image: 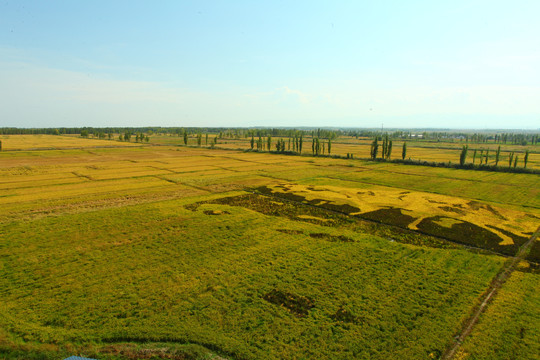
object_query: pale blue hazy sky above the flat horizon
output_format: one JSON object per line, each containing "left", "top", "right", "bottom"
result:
{"left": 0, "top": 0, "right": 540, "bottom": 129}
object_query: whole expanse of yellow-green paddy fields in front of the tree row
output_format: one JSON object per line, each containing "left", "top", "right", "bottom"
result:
{"left": 0, "top": 135, "right": 540, "bottom": 360}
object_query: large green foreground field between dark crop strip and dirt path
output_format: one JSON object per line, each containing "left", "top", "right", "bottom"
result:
{"left": 0, "top": 193, "right": 503, "bottom": 359}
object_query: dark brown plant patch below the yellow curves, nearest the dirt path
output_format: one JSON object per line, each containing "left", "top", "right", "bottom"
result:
{"left": 417, "top": 216, "right": 519, "bottom": 255}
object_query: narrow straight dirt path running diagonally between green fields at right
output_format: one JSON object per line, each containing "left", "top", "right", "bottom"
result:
{"left": 441, "top": 227, "right": 540, "bottom": 360}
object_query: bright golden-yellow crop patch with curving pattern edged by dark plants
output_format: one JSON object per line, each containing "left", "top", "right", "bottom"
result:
{"left": 260, "top": 184, "right": 539, "bottom": 246}
